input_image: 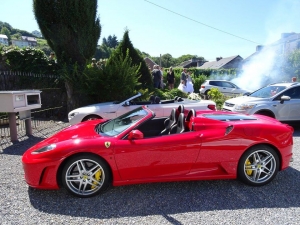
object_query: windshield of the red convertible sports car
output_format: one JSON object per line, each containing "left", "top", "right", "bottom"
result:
{"left": 96, "top": 107, "right": 148, "bottom": 136}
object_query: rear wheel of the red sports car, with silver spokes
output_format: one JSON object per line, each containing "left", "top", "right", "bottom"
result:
{"left": 238, "top": 145, "right": 279, "bottom": 186}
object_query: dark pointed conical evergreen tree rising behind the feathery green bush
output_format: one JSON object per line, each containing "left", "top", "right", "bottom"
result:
{"left": 112, "top": 30, "right": 153, "bottom": 89}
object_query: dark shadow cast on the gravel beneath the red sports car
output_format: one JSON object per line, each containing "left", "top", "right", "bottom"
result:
{"left": 28, "top": 167, "right": 300, "bottom": 220}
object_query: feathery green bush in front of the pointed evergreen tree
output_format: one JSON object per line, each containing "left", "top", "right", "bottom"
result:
{"left": 78, "top": 51, "right": 140, "bottom": 103}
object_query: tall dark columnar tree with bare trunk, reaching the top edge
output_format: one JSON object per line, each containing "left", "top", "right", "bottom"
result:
{"left": 33, "top": 0, "right": 101, "bottom": 110}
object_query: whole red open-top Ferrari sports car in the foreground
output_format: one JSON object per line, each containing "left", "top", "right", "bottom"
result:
{"left": 22, "top": 105, "right": 293, "bottom": 197}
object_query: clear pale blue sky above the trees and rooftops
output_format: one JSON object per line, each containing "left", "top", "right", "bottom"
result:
{"left": 0, "top": 0, "right": 300, "bottom": 61}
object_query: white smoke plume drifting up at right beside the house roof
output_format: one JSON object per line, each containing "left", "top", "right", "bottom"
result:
{"left": 227, "top": 0, "right": 300, "bottom": 91}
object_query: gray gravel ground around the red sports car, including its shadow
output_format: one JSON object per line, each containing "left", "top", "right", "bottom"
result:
{"left": 0, "top": 122, "right": 300, "bottom": 225}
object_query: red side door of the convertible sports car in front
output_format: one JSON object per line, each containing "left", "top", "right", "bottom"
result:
{"left": 114, "top": 132, "right": 201, "bottom": 180}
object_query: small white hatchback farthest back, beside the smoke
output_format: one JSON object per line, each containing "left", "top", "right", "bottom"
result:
{"left": 199, "top": 80, "right": 251, "bottom": 97}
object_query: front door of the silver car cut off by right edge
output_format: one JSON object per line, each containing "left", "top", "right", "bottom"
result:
{"left": 272, "top": 86, "right": 300, "bottom": 121}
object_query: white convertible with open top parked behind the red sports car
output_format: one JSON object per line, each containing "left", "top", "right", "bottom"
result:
{"left": 68, "top": 93, "right": 216, "bottom": 124}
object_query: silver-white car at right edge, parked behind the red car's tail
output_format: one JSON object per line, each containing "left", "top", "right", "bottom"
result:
{"left": 222, "top": 82, "right": 300, "bottom": 122}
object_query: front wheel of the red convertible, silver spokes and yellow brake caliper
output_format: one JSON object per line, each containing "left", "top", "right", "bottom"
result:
{"left": 61, "top": 154, "right": 111, "bottom": 198}
